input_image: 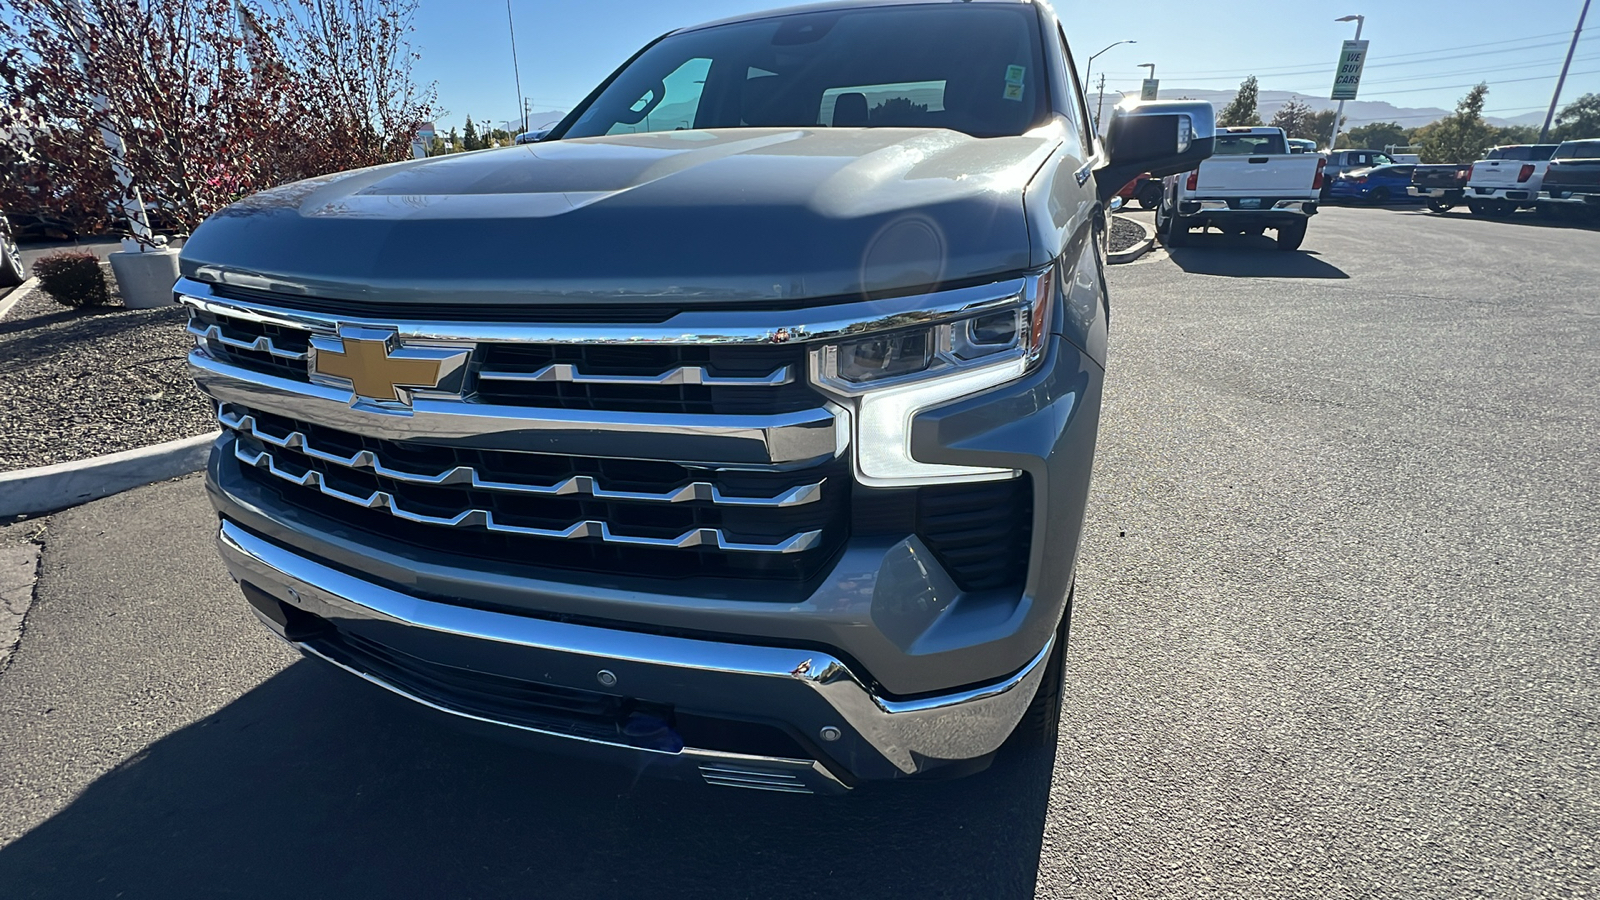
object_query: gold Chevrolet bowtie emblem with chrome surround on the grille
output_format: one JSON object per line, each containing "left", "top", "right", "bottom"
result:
{"left": 310, "top": 327, "right": 469, "bottom": 404}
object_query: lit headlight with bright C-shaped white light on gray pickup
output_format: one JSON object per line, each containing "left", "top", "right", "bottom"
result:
{"left": 811, "top": 267, "right": 1056, "bottom": 487}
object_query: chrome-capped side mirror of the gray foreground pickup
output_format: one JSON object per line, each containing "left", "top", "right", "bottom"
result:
{"left": 1094, "top": 99, "right": 1216, "bottom": 203}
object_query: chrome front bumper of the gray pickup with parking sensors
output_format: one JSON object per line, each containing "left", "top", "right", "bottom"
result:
{"left": 218, "top": 520, "right": 1053, "bottom": 793}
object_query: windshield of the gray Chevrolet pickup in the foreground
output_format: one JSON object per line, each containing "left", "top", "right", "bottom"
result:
{"left": 554, "top": 5, "right": 1046, "bottom": 138}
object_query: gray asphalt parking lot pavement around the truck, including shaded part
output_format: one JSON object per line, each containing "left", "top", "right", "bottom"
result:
{"left": 0, "top": 208, "right": 1600, "bottom": 898}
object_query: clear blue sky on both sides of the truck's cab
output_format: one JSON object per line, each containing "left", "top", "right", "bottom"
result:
{"left": 413, "top": 0, "right": 1600, "bottom": 128}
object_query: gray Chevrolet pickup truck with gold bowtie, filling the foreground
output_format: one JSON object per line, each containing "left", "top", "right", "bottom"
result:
{"left": 176, "top": 0, "right": 1213, "bottom": 793}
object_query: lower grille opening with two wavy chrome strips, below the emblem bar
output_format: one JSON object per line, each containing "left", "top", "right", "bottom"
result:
{"left": 228, "top": 404, "right": 850, "bottom": 581}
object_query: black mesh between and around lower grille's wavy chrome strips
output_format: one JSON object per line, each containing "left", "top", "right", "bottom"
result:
{"left": 230, "top": 412, "right": 850, "bottom": 589}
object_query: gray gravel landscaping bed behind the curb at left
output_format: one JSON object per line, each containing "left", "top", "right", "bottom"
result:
{"left": 0, "top": 267, "right": 216, "bottom": 471}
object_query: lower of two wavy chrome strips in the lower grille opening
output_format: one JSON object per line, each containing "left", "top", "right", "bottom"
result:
{"left": 234, "top": 440, "right": 822, "bottom": 552}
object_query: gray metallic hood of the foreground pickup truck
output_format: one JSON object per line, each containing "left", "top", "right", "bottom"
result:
{"left": 182, "top": 128, "right": 1058, "bottom": 306}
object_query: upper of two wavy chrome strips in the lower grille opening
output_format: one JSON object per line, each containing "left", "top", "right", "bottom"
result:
{"left": 216, "top": 407, "right": 827, "bottom": 509}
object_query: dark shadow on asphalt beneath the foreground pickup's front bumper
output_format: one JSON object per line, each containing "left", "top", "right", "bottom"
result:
{"left": 0, "top": 661, "right": 1054, "bottom": 900}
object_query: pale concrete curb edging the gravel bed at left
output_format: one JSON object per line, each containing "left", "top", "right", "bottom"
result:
{"left": 0, "top": 431, "right": 221, "bottom": 519}
